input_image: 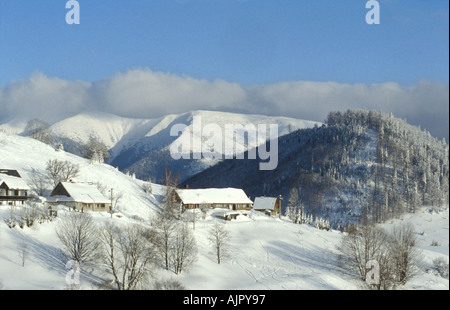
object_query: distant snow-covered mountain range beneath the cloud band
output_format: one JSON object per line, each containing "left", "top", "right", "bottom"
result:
{"left": 1, "top": 110, "right": 320, "bottom": 181}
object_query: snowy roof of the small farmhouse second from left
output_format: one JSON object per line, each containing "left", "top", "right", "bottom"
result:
{"left": 48, "top": 182, "right": 111, "bottom": 204}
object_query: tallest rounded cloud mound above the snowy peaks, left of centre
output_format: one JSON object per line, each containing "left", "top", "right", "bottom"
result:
{"left": 91, "top": 70, "right": 246, "bottom": 118}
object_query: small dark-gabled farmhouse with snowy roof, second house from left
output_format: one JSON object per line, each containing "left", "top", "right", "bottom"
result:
{"left": 47, "top": 181, "right": 111, "bottom": 211}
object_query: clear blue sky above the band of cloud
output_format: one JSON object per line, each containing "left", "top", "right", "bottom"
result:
{"left": 0, "top": 0, "right": 449, "bottom": 85}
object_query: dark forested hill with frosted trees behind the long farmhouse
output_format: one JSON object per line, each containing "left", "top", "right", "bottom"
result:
{"left": 185, "top": 110, "right": 449, "bottom": 227}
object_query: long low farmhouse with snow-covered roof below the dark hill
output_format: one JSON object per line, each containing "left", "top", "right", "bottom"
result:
{"left": 176, "top": 188, "right": 253, "bottom": 210}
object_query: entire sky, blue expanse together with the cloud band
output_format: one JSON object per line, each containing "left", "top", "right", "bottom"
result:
{"left": 0, "top": 0, "right": 449, "bottom": 137}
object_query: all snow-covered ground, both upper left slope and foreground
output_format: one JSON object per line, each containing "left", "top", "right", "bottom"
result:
{"left": 0, "top": 132, "right": 449, "bottom": 290}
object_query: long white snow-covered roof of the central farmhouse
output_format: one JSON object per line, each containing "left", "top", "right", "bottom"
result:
{"left": 177, "top": 188, "right": 253, "bottom": 204}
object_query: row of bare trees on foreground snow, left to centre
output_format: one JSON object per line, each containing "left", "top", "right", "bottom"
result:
{"left": 50, "top": 170, "right": 230, "bottom": 290}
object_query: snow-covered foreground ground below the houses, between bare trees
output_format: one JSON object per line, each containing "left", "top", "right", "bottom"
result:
{"left": 0, "top": 205, "right": 449, "bottom": 290}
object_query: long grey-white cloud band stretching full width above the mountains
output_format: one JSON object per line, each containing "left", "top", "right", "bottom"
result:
{"left": 0, "top": 69, "right": 449, "bottom": 140}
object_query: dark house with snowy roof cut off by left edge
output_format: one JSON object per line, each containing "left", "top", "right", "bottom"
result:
{"left": 0, "top": 169, "right": 30, "bottom": 206}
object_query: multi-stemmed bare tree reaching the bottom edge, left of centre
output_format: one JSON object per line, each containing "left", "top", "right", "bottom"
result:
{"left": 100, "top": 223, "right": 155, "bottom": 290}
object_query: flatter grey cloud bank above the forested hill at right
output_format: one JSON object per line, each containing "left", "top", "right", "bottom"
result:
{"left": 251, "top": 81, "right": 449, "bottom": 141}
